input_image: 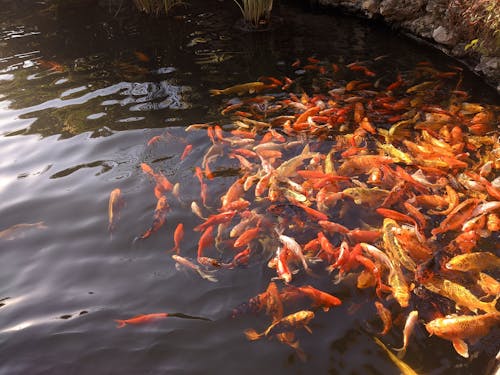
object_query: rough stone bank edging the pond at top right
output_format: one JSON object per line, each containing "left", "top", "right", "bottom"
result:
{"left": 317, "top": 0, "right": 500, "bottom": 92}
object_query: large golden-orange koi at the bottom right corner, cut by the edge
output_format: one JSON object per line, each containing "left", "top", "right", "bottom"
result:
{"left": 425, "top": 312, "right": 500, "bottom": 358}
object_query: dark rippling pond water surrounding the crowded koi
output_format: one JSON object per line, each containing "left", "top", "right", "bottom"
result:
{"left": 0, "top": 1, "right": 498, "bottom": 374}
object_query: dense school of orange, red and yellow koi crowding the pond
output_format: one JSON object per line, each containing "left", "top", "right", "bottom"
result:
{"left": 108, "top": 57, "right": 500, "bottom": 373}
